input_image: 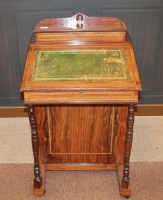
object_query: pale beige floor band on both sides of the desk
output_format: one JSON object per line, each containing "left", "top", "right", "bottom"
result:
{"left": 0, "top": 116, "right": 163, "bottom": 163}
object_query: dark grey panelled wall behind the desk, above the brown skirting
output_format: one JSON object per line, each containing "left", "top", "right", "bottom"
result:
{"left": 0, "top": 0, "right": 163, "bottom": 106}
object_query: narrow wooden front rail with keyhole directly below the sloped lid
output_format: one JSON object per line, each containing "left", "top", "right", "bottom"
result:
{"left": 24, "top": 91, "right": 138, "bottom": 104}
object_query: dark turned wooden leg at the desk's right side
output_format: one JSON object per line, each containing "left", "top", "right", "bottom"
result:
{"left": 122, "top": 104, "right": 134, "bottom": 189}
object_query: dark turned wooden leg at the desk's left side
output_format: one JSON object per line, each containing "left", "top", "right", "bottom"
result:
{"left": 28, "top": 104, "right": 42, "bottom": 188}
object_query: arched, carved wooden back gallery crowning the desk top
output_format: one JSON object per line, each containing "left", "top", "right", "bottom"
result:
{"left": 35, "top": 13, "right": 127, "bottom": 32}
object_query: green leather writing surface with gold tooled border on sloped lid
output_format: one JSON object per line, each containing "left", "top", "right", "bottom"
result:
{"left": 32, "top": 49, "right": 129, "bottom": 82}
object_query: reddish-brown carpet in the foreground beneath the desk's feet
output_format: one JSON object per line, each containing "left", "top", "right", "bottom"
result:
{"left": 0, "top": 162, "right": 163, "bottom": 200}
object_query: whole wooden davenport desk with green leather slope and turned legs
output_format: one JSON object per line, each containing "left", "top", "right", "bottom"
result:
{"left": 21, "top": 13, "right": 141, "bottom": 197}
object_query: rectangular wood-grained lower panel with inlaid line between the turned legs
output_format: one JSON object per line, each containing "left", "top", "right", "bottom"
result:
{"left": 36, "top": 105, "right": 127, "bottom": 164}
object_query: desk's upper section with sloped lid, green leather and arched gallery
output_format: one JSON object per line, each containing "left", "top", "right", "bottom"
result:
{"left": 21, "top": 13, "right": 141, "bottom": 104}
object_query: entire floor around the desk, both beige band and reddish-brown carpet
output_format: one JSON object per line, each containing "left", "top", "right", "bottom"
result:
{"left": 0, "top": 116, "right": 163, "bottom": 200}
